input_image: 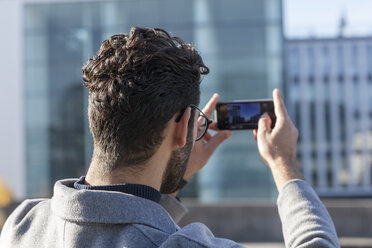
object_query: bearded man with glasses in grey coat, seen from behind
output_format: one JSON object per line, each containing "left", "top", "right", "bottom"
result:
{"left": 0, "top": 28, "right": 339, "bottom": 247}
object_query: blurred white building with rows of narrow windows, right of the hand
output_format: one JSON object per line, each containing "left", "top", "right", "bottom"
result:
{"left": 285, "top": 36, "right": 372, "bottom": 196}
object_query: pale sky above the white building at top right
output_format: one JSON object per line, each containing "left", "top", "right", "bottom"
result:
{"left": 283, "top": 0, "right": 372, "bottom": 38}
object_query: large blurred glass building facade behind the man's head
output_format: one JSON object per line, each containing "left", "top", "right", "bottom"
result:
{"left": 24, "top": 0, "right": 283, "bottom": 201}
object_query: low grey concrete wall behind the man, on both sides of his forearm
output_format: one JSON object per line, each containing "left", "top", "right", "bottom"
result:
{"left": 180, "top": 199, "right": 372, "bottom": 242}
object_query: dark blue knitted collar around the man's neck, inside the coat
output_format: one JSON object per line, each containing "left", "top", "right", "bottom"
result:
{"left": 74, "top": 176, "right": 161, "bottom": 203}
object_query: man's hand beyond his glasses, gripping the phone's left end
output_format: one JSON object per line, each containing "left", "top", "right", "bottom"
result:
{"left": 184, "top": 94, "right": 232, "bottom": 180}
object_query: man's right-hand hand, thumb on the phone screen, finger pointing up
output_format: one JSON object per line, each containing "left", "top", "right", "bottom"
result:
{"left": 253, "top": 89, "right": 302, "bottom": 191}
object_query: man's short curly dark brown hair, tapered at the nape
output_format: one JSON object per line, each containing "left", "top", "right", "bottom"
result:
{"left": 82, "top": 27, "right": 209, "bottom": 171}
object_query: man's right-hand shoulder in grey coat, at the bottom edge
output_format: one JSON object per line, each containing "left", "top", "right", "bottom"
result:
{"left": 161, "top": 223, "right": 242, "bottom": 248}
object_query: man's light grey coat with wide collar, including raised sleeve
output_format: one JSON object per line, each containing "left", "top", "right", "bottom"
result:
{"left": 0, "top": 179, "right": 339, "bottom": 248}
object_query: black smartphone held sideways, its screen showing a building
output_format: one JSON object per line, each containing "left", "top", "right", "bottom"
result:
{"left": 214, "top": 99, "right": 276, "bottom": 130}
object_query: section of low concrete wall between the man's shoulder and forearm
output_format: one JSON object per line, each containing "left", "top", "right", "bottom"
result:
{"left": 180, "top": 202, "right": 283, "bottom": 242}
